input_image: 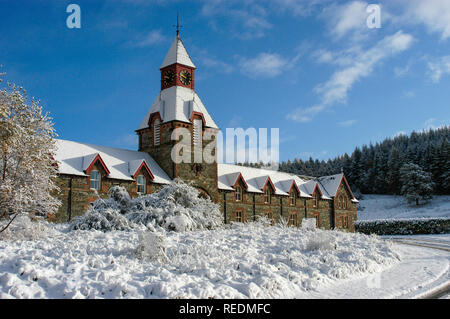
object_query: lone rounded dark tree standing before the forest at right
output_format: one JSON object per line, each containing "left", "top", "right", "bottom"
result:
{"left": 400, "top": 163, "right": 434, "bottom": 205}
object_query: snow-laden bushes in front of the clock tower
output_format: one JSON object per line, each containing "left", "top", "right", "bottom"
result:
{"left": 71, "top": 181, "right": 223, "bottom": 231}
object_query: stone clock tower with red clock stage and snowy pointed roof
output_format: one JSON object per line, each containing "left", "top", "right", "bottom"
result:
{"left": 136, "top": 29, "right": 219, "bottom": 202}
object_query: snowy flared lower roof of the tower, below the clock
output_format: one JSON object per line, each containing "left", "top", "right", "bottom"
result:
{"left": 138, "top": 86, "right": 218, "bottom": 130}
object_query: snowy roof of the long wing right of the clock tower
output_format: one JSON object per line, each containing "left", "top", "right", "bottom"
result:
{"left": 217, "top": 164, "right": 311, "bottom": 197}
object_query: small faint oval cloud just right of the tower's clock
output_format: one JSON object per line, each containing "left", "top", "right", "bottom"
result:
{"left": 239, "top": 53, "right": 289, "bottom": 78}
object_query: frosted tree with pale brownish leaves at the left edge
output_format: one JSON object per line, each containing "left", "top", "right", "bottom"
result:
{"left": 0, "top": 76, "right": 60, "bottom": 224}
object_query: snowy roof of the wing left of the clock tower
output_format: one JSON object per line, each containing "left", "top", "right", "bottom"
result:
{"left": 55, "top": 139, "right": 171, "bottom": 184}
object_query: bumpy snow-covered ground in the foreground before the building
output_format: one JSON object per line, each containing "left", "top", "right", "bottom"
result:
{"left": 0, "top": 218, "right": 401, "bottom": 298}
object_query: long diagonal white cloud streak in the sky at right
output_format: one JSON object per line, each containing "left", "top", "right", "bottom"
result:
{"left": 287, "top": 31, "right": 413, "bottom": 122}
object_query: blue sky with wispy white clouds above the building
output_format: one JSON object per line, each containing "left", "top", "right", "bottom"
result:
{"left": 0, "top": 0, "right": 450, "bottom": 160}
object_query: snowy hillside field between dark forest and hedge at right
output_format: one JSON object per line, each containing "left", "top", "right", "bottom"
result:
{"left": 358, "top": 195, "right": 450, "bottom": 220}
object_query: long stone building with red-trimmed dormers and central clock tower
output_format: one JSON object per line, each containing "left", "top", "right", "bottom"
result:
{"left": 52, "top": 34, "right": 358, "bottom": 231}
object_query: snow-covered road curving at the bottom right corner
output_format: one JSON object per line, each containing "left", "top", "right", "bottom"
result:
{"left": 298, "top": 239, "right": 450, "bottom": 299}
